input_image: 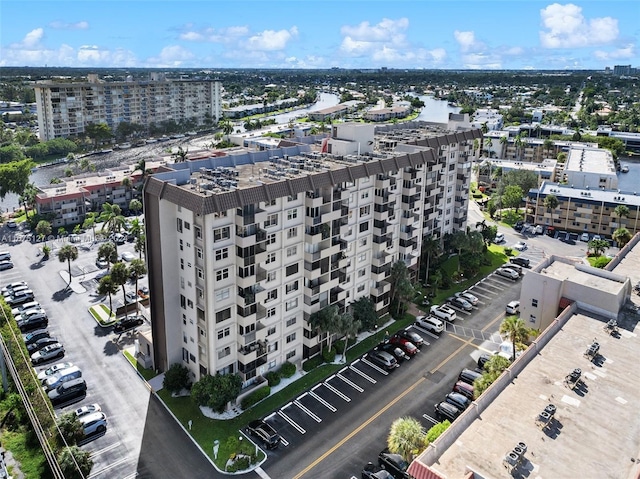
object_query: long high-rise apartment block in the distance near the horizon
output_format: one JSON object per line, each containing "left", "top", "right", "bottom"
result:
{"left": 34, "top": 73, "right": 222, "bottom": 140}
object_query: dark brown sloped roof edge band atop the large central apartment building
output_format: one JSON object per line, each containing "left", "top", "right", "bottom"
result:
{"left": 145, "top": 129, "right": 482, "bottom": 215}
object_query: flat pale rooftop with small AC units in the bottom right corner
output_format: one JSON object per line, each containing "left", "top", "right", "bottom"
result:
{"left": 431, "top": 311, "right": 640, "bottom": 479}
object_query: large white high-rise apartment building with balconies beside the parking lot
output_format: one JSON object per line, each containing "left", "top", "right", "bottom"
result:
{"left": 144, "top": 123, "right": 481, "bottom": 382}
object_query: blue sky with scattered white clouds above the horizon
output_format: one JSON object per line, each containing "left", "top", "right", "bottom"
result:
{"left": 0, "top": 0, "right": 640, "bottom": 69}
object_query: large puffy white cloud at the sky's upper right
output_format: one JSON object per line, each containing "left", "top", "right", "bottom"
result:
{"left": 540, "top": 3, "right": 618, "bottom": 48}
